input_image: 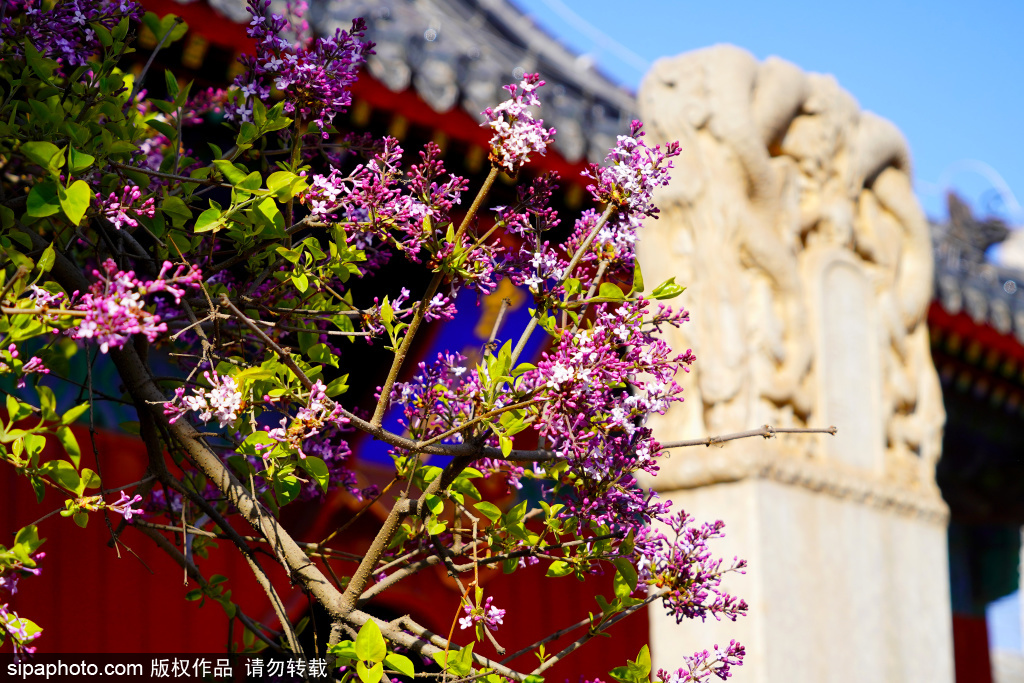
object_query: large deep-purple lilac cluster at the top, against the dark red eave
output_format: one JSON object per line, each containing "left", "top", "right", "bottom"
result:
{"left": 226, "top": 0, "right": 373, "bottom": 133}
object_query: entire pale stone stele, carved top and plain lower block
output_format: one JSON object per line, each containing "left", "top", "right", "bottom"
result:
{"left": 639, "top": 45, "right": 953, "bottom": 683}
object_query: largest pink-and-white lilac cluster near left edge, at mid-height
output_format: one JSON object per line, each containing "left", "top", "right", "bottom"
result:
{"left": 70, "top": 259, "right": 201, "bottom": 353}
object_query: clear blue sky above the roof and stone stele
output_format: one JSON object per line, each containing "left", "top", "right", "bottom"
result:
{"left": 513, "top": 0, "right": 1024, "bottom": 225}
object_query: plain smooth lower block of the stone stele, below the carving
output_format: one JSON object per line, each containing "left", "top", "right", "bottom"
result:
{"left": 650, "top": 478, "right": 953, "bottom": 683}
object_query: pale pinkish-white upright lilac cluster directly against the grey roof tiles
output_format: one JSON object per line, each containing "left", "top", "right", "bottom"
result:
{"left": 482, "top": 74, "right": 555, "bottom": 175}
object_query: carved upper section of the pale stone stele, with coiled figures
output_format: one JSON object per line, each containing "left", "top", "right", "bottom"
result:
{"left": 639, "top": 45, "right": 945, "bottom": 498}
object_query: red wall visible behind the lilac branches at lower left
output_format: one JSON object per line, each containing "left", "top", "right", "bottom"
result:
{"left": 0, "top": 429, "right": 648, "bottom": 683}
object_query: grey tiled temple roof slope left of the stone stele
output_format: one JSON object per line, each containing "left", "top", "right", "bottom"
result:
{"left": 186, "top": 0, "right": 637, "bottom": 163}
